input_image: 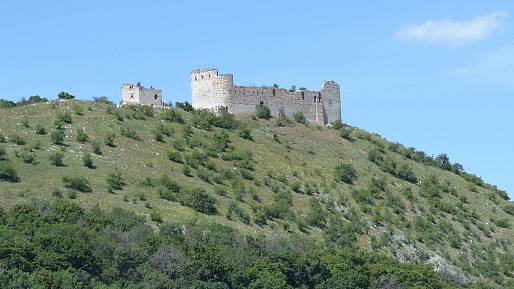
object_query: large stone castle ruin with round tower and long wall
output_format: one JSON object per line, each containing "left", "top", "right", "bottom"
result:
{"left": 191, "top": 69, "right": 341, "bottom": 125}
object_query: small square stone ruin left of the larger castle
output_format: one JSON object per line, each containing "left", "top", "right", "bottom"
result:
{"left": 121, "top": 82, "right": 164, "bottom": 107}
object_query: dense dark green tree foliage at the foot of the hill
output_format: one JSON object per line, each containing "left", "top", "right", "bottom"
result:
{"left": 0, "top": 201, "right": 476, "bottom": 289}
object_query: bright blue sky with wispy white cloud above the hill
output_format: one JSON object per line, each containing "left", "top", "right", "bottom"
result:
{"left": 0, "top": 0, "right": 514, "bottom": 197}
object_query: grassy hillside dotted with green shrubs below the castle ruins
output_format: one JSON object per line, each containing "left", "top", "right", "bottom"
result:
{"left": 0, "top": 101, "right": 514, "bottom": 287}
